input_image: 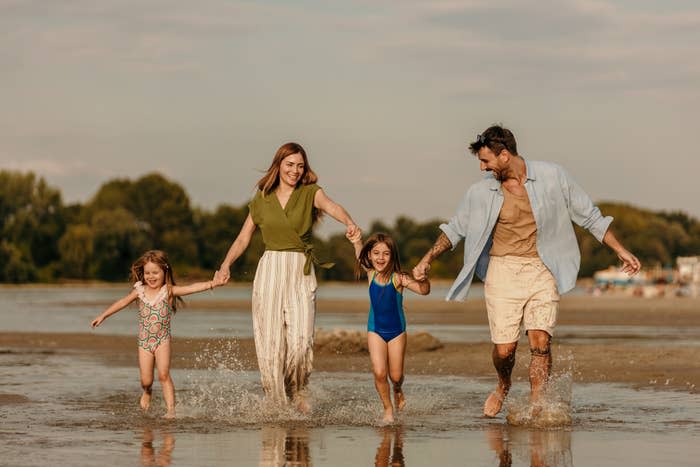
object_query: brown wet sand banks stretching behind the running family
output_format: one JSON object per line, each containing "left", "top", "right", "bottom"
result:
{"left": 0, "top": 296, "right": 700, "bottom": 394}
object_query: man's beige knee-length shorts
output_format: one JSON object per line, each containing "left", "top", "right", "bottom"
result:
{"left": 484, "top": 256, "right": 559, "bottom": 344}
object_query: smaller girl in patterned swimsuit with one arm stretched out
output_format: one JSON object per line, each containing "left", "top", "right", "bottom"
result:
{"left": 92, "top": 250, "right": 223, "bottom": 418}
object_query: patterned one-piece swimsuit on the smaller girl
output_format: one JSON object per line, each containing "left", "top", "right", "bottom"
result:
{"left": 134, "top": 281, "right": 173, "bottom": 353}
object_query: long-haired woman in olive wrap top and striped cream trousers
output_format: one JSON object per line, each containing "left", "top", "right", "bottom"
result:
{"left": 217, "top": 143, "right": 359, "bottom": 412}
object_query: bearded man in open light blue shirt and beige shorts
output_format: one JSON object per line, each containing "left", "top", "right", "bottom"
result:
{"left": 413, "top": 125, "right": 641, "bottom": 417}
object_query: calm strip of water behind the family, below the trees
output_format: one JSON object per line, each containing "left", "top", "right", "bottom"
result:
{"left": 0, "top": 284, "right": 700, "bottom": 346}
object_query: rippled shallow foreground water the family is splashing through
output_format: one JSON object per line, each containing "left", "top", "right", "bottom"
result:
{"left": 0, "top": 349, "right": 700, "bottom": 466}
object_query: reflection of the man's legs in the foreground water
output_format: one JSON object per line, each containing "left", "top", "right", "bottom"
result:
{"left": 486, "top": 425, "right": 574, "bottom": 467}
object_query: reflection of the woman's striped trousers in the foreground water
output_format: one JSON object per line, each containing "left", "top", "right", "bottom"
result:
{"left": 260, "top": 426, "right": 312, "bottom": 467}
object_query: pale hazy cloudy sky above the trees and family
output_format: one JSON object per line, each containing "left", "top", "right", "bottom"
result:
{"left": 0, "top": 0, "right": 700, "bottom": 238}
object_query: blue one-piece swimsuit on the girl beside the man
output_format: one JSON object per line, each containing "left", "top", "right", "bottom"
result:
{"left": 367, "top": 271, "right": 406, "bottom": 342}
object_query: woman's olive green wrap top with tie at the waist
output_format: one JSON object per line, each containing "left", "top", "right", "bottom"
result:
{"left": 248, "top": 183, "right": 333, "bottom": 275}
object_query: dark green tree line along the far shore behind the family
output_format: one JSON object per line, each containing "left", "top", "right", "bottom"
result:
{"left": 0, "top": 170, "right": 700, "bottom": 283}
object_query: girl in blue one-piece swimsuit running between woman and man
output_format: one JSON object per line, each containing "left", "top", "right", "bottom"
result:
{"left": 347, "top": 230, "right": 430, "bottom": 423}
